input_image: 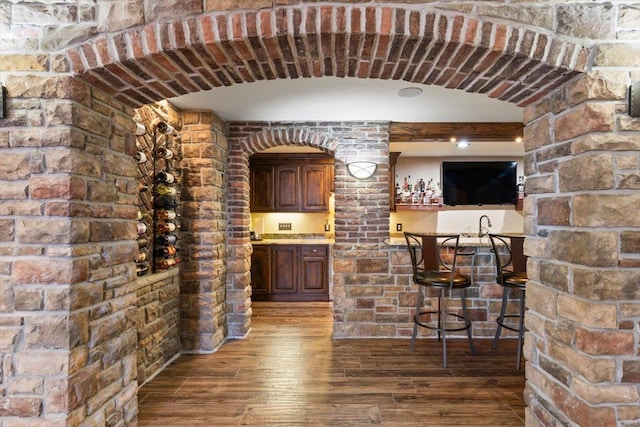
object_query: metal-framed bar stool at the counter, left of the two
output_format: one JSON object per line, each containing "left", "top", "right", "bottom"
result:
{"left": 404, "top": 232, "right": 476, "bottom": 368}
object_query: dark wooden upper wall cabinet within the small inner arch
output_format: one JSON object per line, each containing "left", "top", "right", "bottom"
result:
{"left": 250, "top": 154, "right": 333, "bottom": 212}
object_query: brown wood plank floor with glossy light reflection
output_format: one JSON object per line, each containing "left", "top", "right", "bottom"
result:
{"left": 139, "top": 302, "right": 525, "bottom": 427}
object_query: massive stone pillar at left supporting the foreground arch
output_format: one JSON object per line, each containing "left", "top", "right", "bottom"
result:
{"left": 0, "top": 76, "right": 138, "bottom": 425}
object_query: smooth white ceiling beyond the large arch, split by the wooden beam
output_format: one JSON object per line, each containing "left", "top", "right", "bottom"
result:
{"left": 169, "top": 77, "right": 524, "bottom": 157}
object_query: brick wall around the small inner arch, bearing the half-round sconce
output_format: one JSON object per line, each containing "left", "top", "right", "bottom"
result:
{"left": 227, "top": 122, "right": 393, "bottom": 337}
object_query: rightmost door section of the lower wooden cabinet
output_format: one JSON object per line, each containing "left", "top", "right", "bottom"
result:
{"left": 300, "top": 245, "right": 329, "bottom": 297}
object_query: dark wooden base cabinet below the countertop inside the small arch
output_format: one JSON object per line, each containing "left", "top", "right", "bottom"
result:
{"left": 251, "top": 245, "right": 329, "bottom": 301}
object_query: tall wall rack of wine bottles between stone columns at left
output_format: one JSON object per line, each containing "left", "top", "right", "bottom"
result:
{"left": 136, "top": 121, "right": 181, "bottom": 276}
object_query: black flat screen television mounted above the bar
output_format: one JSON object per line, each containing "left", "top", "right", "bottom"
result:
{"left": 442, "top": 161, "right": 517, "bottom": 205}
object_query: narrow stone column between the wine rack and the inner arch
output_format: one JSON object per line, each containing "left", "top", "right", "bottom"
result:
{"left": 180, "top": 111, "right": 227, "bottom": 353}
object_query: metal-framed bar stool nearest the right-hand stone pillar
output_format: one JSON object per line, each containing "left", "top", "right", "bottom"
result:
{"left": 489, "top": 234, "right": 527, "bottom": 369}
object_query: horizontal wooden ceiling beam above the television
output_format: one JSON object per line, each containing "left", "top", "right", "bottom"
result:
{"left": 389, "top": 122, "right": 524, "bottom": 142}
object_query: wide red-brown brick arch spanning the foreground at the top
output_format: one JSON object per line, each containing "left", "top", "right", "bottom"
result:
{"left": 67, "top": 5, "right": 592, "bottom": 107}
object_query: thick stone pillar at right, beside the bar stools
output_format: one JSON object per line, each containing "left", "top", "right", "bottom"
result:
{"left": 525, "top": 72, "right": 640, "bottom": 426}
